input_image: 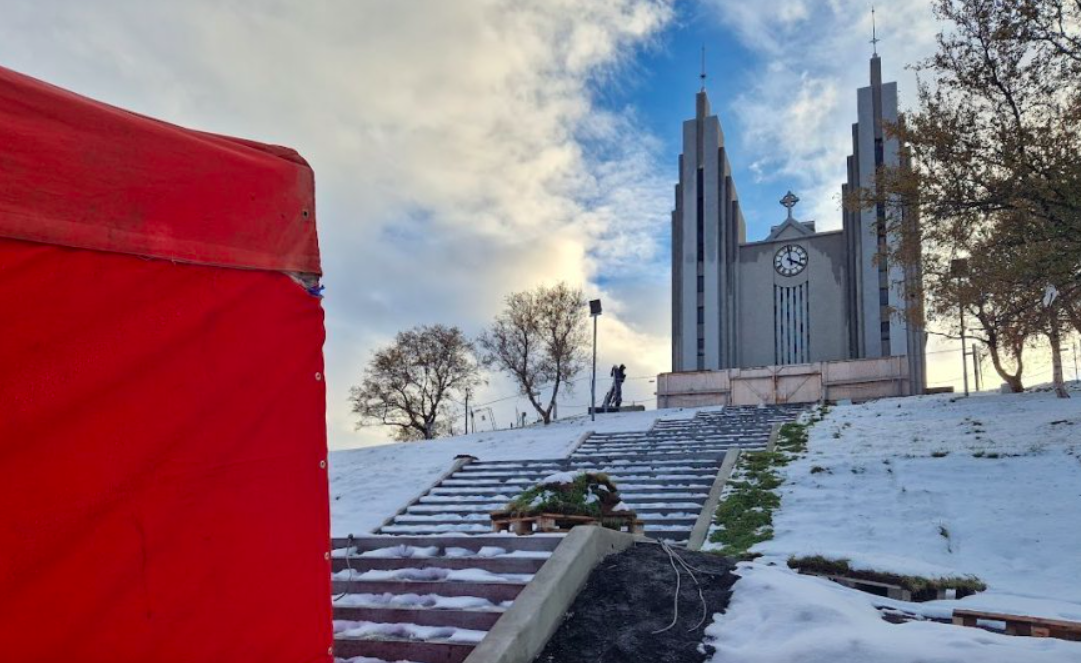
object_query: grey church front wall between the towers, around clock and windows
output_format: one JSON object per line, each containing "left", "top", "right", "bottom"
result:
{"left": 738, "top": 233, "right": 849, "bottom": 368}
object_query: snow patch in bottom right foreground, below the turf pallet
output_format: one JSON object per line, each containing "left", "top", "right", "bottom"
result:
{"left": 706, "top": 563, "right": 1081, "bottom": 663}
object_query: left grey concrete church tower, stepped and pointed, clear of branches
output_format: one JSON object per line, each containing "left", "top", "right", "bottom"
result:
{"left": 671, "top": 84, "right": 746, "bottom": 371}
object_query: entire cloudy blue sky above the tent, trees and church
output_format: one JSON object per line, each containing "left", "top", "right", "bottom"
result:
{"left": 0, "top": 0, "right": 1063, "bottom": 448}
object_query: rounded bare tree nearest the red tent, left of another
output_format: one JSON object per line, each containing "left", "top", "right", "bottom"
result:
{"left": 349, "top": 324, "right": 481, "bottom": 440}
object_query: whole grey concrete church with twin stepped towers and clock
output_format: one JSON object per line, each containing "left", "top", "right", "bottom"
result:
{"left": 671, "top": 52, "right": 926, "bottom": 394}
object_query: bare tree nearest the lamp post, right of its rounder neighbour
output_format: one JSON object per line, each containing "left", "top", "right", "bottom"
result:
{"left": 479, "top": 282, "right": 587, "bottom": 424}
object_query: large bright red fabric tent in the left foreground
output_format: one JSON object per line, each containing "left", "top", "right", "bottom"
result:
{"left": 0, "top": 68, "right": 332, "bottom": 663}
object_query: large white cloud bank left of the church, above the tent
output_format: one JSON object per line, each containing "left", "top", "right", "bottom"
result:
{"left": 0, "top": 0, "right": 672, "bottom": 446}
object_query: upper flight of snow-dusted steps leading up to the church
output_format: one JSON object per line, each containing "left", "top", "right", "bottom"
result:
{"left": 378, "top": 406, "right": 801, "bottom": 544}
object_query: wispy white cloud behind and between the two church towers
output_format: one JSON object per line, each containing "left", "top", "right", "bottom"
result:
{"left": 702, "top": 0, "right": 938, "bottom": 224}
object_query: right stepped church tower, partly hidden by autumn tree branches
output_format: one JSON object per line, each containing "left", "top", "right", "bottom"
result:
{"left": 841, "top": 46, "right": 926, "bottom": 394}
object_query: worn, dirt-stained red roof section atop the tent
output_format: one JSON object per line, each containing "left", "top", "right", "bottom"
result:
{"left": 0, "top": 67, "right": 321, "bottom": 274}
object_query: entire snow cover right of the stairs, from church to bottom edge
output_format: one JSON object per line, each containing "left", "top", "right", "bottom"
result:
{"left": 709, "top": 393, "right": 1081, "bottom": 663}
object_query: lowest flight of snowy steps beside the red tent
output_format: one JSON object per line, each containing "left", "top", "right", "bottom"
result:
{"left": 331, "top": 535, "right": 563, "bottom": 663}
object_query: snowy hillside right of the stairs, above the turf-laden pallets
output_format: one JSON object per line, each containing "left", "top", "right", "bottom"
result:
{"left": 755, "top": 387, "right": 1081, "bottom": 621}
